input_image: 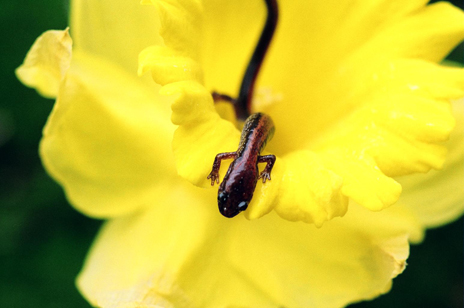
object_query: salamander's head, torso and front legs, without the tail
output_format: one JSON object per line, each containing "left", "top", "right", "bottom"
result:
{"left": 208, "top": 113, "right": 276, "bottom": 218}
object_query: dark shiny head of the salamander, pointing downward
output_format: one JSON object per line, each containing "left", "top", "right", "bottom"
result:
{"left": 218, "top": 171, "right": 258, "bottom": 218}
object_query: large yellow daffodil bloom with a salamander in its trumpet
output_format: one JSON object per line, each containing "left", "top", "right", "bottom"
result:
{"left": 17, "top": 0, "right": 464, "bottom": 308}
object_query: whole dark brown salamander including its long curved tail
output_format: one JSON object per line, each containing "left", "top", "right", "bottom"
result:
{"left": 208, "top": 0, "right": 278, "bottom": 218}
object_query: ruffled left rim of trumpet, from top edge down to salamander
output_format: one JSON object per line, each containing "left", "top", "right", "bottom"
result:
{"left": 139, "top": 1, "right": 240, "bottom": 187}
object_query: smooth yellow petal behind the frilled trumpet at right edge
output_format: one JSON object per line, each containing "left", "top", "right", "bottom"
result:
{"left": 398, "top": 99, "right": 464, "bottom": 227}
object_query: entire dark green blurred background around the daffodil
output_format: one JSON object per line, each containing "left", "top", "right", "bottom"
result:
{"left": 0, "top": 0, "right": 464, "bottom": 308}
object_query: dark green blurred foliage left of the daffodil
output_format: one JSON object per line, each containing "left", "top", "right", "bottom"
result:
{"left": 0, "top": 0, "right": 100, "bottom": 308}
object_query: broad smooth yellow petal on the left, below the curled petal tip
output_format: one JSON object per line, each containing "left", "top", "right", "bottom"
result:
{"left": 40, "top": 53, "right": 175, "bottom": 217}
